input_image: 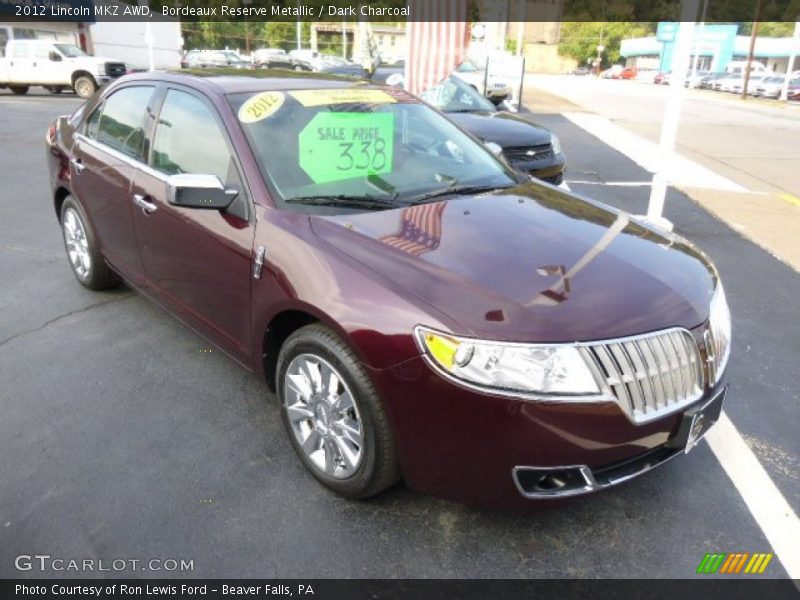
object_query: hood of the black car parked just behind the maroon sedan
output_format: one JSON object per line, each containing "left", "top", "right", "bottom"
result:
{"left": 447, "top": 111, "right": 550, "bottom": 148}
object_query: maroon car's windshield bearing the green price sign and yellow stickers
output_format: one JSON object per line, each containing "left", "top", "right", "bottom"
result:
{"left": 229, "top": 87, "right": 518, "bottom": 211}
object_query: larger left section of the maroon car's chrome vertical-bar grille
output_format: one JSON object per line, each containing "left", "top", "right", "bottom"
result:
{"left": 580, "top": 329, "right": 703, "bottom": 423}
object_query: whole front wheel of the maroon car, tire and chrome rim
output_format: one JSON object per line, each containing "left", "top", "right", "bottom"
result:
{"left": 277, "top": 323, "right": 400, "bottom": 498}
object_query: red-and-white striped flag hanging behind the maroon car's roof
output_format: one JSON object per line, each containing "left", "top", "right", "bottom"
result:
{"left": 405, "top": 0, "right": 469, "bottom": 94}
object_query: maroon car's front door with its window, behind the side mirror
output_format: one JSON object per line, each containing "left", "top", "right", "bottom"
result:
{"left": 132, "top": 87, "right": 255, "bottom": 364}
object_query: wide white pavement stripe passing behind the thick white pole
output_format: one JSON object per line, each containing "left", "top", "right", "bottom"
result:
{"left": 562, "top": 112, "right": 747, "bottom": 192}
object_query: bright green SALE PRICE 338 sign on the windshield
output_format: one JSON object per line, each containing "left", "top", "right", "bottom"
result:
{"left": 298, "top": 112, "right": 394, "bottom": 183}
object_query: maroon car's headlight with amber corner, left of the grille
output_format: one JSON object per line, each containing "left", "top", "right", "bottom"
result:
{"left": 416, "top": 327, "right": 600, "bottom": 397}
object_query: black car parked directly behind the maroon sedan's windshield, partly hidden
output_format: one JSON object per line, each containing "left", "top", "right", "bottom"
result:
{"left": 422, "top": 77, "right": 566, "bottom": 185}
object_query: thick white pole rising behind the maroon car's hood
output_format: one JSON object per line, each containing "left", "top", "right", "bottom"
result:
{"left": 647, "top": 0, "right": 699, "bottom": 231}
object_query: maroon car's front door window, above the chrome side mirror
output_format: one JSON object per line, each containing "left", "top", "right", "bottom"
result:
{"left": 152, "top": 90, "right": 238, "bottom": 184}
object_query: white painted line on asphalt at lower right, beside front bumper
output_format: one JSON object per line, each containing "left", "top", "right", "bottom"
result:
{"left": 706, "top": 412, "right": 800, "bottom": 580}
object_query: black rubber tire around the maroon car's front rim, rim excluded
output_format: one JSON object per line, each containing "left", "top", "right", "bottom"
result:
{"left": 276, "top": 328, "right": 390, "bottom": 498}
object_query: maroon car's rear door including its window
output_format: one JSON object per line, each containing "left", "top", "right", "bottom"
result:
{"left": 70, "top": 85, "right": 155, "bottom": 283}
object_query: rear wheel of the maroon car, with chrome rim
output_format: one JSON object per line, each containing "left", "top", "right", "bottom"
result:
{"left": 61, "top": 196, "right": 119, "bottom": 290}
